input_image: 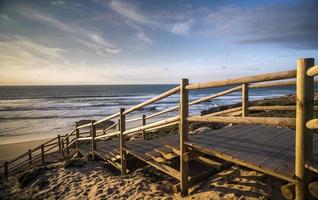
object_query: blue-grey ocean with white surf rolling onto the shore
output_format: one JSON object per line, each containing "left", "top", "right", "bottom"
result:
{"left": 0, "top": 85, "right": 295, "bottom": 144}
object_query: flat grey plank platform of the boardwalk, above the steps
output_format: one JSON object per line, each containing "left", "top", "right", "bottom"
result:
{"left": 188, "top": 125, "right": 318, "bottom": 181}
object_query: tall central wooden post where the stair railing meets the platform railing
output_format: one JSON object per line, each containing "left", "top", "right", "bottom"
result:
{"left": 179, "top": 79, "right": 189, "bottom": 196}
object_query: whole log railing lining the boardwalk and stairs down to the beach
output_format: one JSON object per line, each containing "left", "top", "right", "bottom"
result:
{"left": 4, "top": 59, "right": 318, "bottom": 199}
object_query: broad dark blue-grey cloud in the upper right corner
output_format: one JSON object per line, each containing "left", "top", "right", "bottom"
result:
{"left": 205, "top": 1, "right": 318, "bottom": 49}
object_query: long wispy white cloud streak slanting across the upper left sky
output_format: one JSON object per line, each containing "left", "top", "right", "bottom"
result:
{"left": 22, "top": 8, "right": 121, "bottom": 55}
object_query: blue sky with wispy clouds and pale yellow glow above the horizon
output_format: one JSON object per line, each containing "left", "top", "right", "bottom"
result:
{"left": 0, "top": 0, "right": 318, "bottom": 85}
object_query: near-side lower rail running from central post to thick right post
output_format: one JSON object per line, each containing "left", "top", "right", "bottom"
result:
{"left": 188, "top": 115, "right": 295, "bottom": 127}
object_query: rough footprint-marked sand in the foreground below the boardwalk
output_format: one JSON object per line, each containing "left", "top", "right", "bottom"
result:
{"left": 0, "top": 158, "right": 283, "bottom": 200}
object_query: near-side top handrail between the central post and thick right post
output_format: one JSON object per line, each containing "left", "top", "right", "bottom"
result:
{"left": 186, "top": 70, "right": 296, "bottom": 90}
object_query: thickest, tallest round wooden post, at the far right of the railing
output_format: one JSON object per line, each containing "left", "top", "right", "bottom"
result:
{"left": 295, "top": 58, "right": 314, "bottom": 200}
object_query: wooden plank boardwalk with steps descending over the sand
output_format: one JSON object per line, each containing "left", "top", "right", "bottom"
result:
{"left": 79, "top": 125, "right": 318, "bottom": 181}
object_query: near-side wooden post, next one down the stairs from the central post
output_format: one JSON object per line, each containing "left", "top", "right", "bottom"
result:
{"left": 119, "top": 108, "right": 127, "bottom": 175}
